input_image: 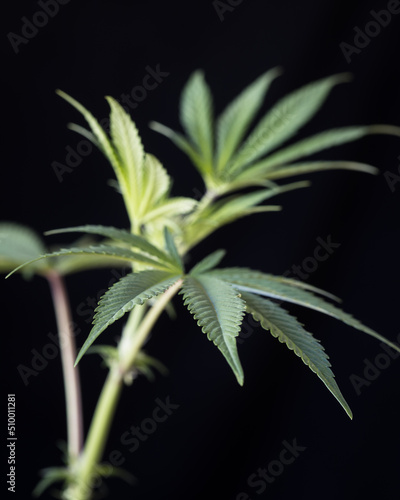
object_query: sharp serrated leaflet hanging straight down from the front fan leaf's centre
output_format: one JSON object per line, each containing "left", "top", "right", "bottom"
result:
{"left": 179, "top": 275, "right": 245, "bottom": 385}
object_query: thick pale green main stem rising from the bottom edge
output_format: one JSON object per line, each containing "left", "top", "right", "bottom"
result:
{"left": 64, "top": 280, "right": 182, "bottom": 500}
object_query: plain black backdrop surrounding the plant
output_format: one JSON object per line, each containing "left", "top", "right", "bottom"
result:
{"left": 0, "top": 0, "right": 400, "bottom": 500}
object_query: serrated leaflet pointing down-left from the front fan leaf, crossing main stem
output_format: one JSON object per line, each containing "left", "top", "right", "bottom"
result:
{"left": 75, "top": 270, "right": 180, "bottom": 366}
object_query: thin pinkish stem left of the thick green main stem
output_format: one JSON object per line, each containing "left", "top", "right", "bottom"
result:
{"left": 45, "top": 271, "right": 83, "bottom": 463}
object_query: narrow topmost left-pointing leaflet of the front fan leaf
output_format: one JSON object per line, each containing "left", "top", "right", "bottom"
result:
{"left": 45, "top": 225, "right": 173, "bottom": 264}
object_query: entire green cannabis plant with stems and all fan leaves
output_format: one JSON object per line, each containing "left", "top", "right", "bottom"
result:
{"left": 0, "top": 69, "right": 400, "bottom": 500}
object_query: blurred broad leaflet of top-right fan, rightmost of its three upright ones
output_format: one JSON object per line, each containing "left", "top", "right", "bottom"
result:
{"left": 229, "top": 74, "right": 348, "bottom": 174}
